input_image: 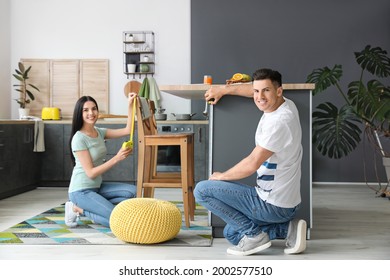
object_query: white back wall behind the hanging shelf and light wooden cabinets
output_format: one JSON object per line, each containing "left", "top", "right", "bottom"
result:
{"left": 8, "top": 0, "right": 191, "bottom": 118}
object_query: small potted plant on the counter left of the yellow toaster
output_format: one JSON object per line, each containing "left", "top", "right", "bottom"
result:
{"left": 12, "top": 62, "right": 39, "bottom": 117}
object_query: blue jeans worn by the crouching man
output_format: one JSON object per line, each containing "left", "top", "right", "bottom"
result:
{"left": 194, "top": 180, "right": 299, "bottom": 245}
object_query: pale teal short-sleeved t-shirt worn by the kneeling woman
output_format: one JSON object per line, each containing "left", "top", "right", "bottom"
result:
{"left": 69, "top": 127, "right": 107, "bottom": 192}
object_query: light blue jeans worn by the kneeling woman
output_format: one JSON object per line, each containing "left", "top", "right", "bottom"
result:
{"left": 69, "top": 182, "right": 137, "bottom": 227}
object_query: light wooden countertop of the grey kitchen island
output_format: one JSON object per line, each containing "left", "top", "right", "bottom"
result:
{"left": 159, "top": 84, "right": 314, "bottom": 99}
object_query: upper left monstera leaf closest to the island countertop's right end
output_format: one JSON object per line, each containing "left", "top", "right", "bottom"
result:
{"left": 306, "top": 64, "right": 343, "bottom": 95}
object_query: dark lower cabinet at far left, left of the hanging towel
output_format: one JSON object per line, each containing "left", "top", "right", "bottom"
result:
{"left": 0, "top": 122, "right": 41, "bottom": 199}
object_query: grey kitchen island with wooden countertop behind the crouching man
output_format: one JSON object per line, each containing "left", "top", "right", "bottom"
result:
{"left": 160, "top": 84, "right": 314, "bottom": 238}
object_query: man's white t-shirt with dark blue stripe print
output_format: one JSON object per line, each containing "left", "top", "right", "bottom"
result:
{"left": 255, "top": 98, "right": 302, "bottom": 208}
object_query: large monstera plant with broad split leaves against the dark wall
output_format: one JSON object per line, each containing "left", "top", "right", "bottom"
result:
{"left": 307, "top": 45, "right": 390, "bottom": 197}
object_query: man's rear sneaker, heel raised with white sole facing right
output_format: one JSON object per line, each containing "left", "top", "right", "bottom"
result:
{"left": 284, "top": 220, "right": 307, "bottom": 255}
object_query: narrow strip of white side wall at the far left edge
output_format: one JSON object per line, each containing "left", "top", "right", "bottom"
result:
{"left": 0, "top": 0, "right": 10, "bottom": 119}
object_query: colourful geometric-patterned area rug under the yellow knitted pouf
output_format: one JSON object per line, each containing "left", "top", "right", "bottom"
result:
{"left": 0, "top": 202, "right": 213, "bottom": 247}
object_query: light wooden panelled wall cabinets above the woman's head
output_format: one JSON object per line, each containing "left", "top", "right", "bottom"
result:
{"left": 21, "top": 59, "right": 109, "bottom": 118}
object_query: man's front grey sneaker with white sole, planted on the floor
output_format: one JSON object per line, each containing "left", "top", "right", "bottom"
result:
{"left": 227, "top": 232, "right": 271, "bottom": 256}
